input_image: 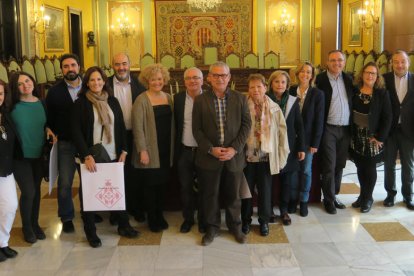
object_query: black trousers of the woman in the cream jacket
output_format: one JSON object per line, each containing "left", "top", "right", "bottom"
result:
{"left": 241, "top": 162, "right": 272, "bottom": 224}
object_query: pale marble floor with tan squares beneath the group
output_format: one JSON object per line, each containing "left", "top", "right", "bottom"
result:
{"left": 0, "top": 163, "right": 414, "bottom": 276}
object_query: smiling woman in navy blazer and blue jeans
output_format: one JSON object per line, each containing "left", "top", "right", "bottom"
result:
{"left": 288, "top": 62, "right": 325, "bottom": 217}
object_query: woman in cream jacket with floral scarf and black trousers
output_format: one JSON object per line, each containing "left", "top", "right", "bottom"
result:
{"left": 241, "top": 74, "right": 289, "bottom": 236}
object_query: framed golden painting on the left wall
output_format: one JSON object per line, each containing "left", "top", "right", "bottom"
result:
{"left": 45, "top": 5, "right": 65, "bottom": 52}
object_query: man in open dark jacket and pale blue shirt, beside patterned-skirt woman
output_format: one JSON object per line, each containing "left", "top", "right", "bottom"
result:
{"left": 315, "top": 50, "right": 354, "bottom": 214}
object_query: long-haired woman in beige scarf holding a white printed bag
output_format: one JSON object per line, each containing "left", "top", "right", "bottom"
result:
{"left": 71, "top": 66, "right": 138, "bottom": 248}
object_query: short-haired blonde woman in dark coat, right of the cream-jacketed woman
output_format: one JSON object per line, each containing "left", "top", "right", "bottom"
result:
{"left": 267, "top": 70, "right": 305, "bottom": 225}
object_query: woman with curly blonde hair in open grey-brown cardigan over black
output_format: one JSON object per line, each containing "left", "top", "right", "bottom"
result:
{"left": 132, "top": 64, "right": 174, "bottom": 232}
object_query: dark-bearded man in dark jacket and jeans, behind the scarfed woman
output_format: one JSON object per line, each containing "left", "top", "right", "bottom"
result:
{"left": 46, "top": 54, "right": 82, "bottom": 233}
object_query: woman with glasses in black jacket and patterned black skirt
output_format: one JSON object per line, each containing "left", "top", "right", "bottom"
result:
{"left": 350, "top": 62, "right": 392, "bottom": 213}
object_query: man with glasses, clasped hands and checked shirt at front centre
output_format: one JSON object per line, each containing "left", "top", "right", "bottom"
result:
{"left": 193, "top": 62, "right": 251, "bottom": 246}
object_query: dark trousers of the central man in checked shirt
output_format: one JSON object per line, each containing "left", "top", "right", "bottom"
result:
{"left": 197, "top": 165, "right": 243, "bottom": 231}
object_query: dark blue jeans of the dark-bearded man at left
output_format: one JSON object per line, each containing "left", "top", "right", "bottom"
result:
{"left": 57, "top": 141, "right": 76, "bottom": 221}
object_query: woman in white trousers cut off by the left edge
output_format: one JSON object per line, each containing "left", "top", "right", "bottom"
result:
{"left": 0, "top": 80, "right": 17, "bottom": 262}
